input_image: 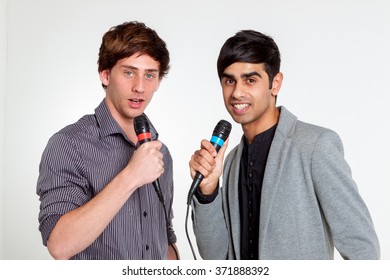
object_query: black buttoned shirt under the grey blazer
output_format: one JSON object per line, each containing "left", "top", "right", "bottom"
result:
{"left": 238, "top": 125, "right": 276, "bottom": 260}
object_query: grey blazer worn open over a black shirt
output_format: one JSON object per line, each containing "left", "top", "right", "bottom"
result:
{"left": 192, "top": 107, "right": 380, "bottom": 260}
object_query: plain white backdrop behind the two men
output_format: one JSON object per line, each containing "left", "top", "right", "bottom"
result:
{"left": 0, "top": 0, "right": 390, "bottom": 259}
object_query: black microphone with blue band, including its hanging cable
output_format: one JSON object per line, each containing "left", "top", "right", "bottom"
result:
{"left": 185, "top": 120, "right": 232, "bottom": 260}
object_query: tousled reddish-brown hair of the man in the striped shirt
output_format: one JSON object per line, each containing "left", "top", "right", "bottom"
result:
{"left": 98, "top": 21, "right": 169, "bottom": 79}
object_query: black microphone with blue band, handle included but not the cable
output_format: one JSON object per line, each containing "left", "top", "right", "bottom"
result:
{"left": 187, "top": 120, "right": 232, "bottom": 205}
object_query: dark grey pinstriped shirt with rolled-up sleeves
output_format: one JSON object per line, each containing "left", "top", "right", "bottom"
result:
{"left": 37, "top": 100, "right": 176, "bottom": 260}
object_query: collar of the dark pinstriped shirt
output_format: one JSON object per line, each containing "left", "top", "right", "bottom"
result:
{"left": 95, "top": 99, "right": 158, "bottom": 141}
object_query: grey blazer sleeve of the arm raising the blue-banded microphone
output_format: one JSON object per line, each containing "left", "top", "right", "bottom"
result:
{"left": 192, "top": 191, "right": 229, "bottom": 260}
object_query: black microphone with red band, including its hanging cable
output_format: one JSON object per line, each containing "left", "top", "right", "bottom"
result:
{"left": 134, "top": 114, "right": 179, "bottom": 260}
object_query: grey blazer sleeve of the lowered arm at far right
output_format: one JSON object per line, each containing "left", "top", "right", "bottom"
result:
{"left": 312, "top": 130, "right": 380, "bottom": 260}
